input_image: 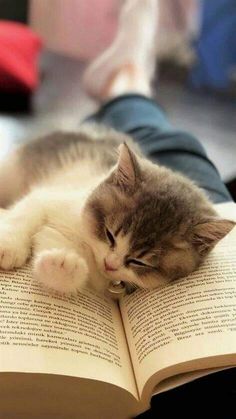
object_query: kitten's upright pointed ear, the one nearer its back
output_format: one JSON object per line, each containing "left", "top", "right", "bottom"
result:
{"left": 115, "top": 143, "right": 140, "bottom": 190}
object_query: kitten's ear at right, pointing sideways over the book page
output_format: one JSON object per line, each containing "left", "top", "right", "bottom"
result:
{"left": 193, "top": 217, "right": 236, "bottom": 256}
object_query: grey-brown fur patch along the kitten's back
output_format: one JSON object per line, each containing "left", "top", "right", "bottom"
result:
{"left": 19, "top": 125, "right": 122, "bottom": 182}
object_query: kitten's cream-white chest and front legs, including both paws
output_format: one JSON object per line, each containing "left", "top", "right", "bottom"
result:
{"left": 0, "top": 161, "right": 97, "bottom": 292}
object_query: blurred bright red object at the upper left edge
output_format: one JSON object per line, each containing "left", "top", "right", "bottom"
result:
{"left": 0, "top": 21, "right": 42, "bottom": 93}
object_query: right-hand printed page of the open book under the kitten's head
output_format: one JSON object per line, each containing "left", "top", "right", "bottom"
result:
{"left": 120, "top": 206, "right": 236, "bottom": 395}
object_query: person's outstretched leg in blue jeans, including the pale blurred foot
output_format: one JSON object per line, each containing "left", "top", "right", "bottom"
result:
{"left": 84, "top": 0, "right": 231, "bottom": 203}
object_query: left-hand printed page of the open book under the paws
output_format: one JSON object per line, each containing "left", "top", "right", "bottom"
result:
{"left": 0, "top": 267, "right": 138, "bottom": 398}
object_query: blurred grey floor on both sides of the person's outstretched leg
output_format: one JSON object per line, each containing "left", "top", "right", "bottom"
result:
{"left": 0, "top": 52, "right": 236, "bottom": 181}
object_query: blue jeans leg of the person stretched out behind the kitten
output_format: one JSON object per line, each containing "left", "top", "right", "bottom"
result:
{"left": 87, "top": 94, "right": 232, "bottom": 207}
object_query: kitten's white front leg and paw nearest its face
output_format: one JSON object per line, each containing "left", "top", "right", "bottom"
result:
{"left": 33, "top": 226, "right": 88, "bottom": 294}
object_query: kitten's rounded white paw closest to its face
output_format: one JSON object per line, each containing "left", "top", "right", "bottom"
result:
{"left": 34, "top": 249, "right": 88, "bottom": 293}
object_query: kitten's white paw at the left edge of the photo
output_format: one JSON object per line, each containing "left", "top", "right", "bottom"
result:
{"left": 0, "top": 229, "right": 30, "bottom": 270}
